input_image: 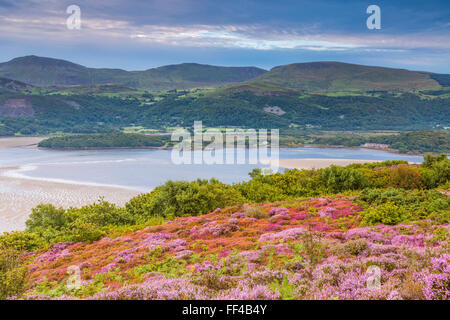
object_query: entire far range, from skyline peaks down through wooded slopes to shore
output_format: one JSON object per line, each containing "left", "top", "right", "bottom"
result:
{"left": 0, "top": 56, "right": 450, "bottom": 136}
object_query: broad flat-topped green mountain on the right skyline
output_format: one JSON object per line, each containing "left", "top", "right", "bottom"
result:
{"left": 230, "top": 62, "right": 449, "bottom": 92}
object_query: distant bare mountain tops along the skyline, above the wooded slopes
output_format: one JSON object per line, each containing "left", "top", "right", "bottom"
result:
{"left": 0, "top": 56, "right": 450, "bottom": 92}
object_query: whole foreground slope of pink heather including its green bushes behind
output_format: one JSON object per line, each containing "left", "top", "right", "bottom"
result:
{"left": 0, "top": 156, "right": 450, "bottom": 300}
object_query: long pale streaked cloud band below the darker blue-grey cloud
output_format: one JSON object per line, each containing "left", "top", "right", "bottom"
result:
{"left": 0, "top": 12, "right": 450, "bottom": 52}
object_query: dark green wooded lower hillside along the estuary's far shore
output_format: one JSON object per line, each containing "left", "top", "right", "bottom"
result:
{"left": 0, "top": 90, "right": 450, "bottom": 135}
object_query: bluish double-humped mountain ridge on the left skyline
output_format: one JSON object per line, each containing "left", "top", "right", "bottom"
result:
{"left": 0, "top": 56, "right": 266, "bottom": 91}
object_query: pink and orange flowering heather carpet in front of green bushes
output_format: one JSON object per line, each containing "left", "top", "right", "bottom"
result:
{"left": 14, "top": 196, "right": 450, "bottom": 300}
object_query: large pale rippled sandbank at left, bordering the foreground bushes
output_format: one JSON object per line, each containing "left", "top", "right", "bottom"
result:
{"left": 0, "top": 167, "right": 140, "bottom": 233}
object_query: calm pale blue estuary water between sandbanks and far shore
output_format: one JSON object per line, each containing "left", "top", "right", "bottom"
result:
{"left": 0, "top": 148, "right": 422, "bottom": 191}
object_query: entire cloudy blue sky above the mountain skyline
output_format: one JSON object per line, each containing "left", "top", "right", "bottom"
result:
{"left": 0, "top": 0, "right": 450, "bottom": 73}
